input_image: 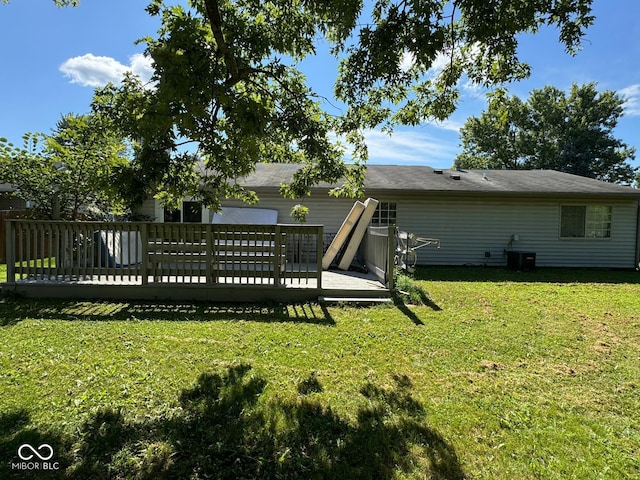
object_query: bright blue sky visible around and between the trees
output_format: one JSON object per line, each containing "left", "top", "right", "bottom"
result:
{"left": 0, "top": 0, "right": 640, "bottom": 168}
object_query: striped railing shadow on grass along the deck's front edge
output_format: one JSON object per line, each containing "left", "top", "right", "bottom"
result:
{"left": 0, "top": 298, "right": 335, "bottom": 326}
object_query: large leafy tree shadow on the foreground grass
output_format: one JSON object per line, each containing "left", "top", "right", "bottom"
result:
{"left": 0, "top": 365, "right": 465, "bottom": 480}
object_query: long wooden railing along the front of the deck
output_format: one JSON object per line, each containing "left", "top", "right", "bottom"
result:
{"left": 6, "top": 220, "right": 323, "bottom": 288}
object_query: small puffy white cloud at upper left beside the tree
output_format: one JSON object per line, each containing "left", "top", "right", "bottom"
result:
{"left": 60, "top": 53, "right": 153, "bottom": 87}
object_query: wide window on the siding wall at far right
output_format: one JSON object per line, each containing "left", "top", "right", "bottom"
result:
{"left": 560, "top": 205, "right": 611, "bottom": 238}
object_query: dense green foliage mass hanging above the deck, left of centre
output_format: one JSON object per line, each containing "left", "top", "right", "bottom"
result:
{"left": 93, "top": 1, "right": 362, "bottom": 208}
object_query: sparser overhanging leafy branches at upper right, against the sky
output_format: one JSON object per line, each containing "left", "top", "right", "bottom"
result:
{"left": 336, "top": 0, "right": 594, "bottom": 125}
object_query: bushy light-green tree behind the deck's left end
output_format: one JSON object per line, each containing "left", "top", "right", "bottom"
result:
{"left": 0, "top": 114, "right": 127, "bottom": 220}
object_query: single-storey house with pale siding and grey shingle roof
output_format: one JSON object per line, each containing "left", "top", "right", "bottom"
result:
{"left": 140, "top": 164, "right": 640, "bottom": 268}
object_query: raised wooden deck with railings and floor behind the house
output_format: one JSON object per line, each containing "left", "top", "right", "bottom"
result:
{"left": 2, "top": 220, "right": 393, "bottom": 302}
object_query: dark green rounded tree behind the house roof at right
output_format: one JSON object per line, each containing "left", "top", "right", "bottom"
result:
{"left": 456, "top": 83, "right": 636, "bottom": 184}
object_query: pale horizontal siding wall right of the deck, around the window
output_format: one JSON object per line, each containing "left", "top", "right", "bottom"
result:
{"left": 380, "top": 197, "right": 638, "bottom": 268}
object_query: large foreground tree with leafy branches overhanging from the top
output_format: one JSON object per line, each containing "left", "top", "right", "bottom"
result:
{"left": 5, "top": 0, "right": 593, "bottom": 208}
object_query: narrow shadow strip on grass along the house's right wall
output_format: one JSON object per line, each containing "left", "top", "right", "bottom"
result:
{"left": 414, "top": 266, "right": 640, "bottom": 284}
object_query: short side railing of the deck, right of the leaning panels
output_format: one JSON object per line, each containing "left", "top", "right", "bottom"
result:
{"left": 364, "top": 226, "right": 396, "bottom": 290}
